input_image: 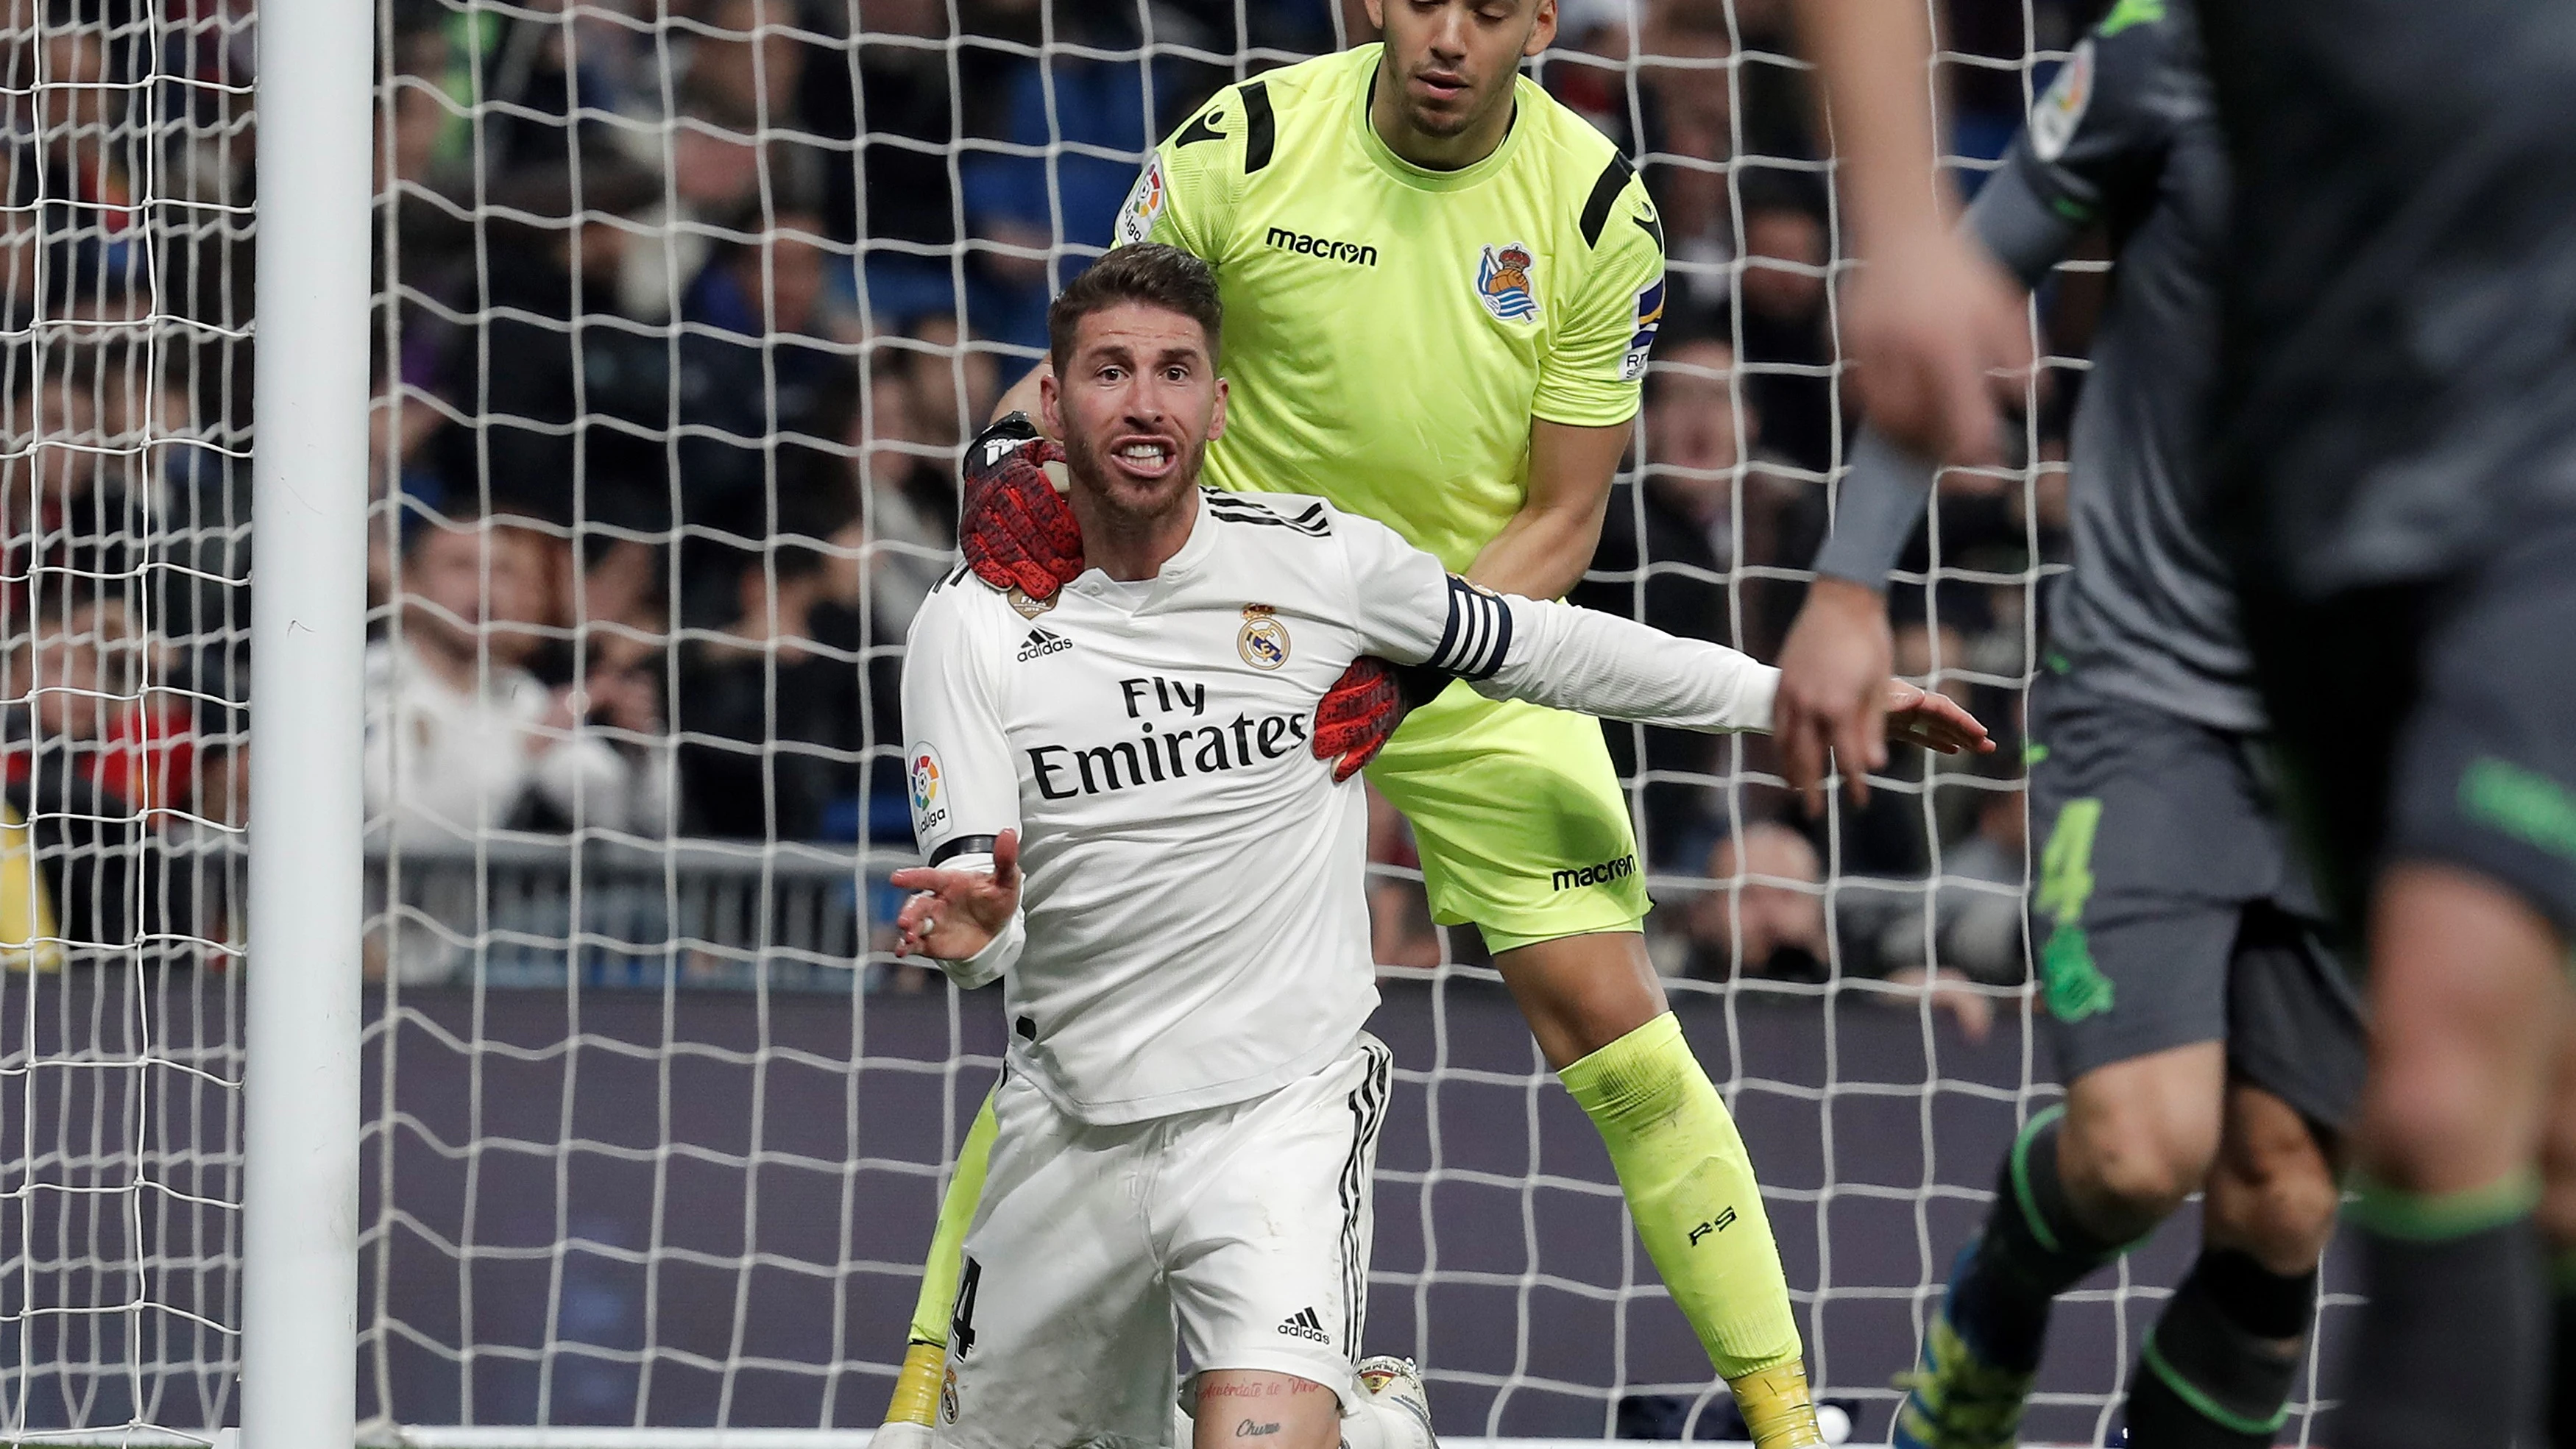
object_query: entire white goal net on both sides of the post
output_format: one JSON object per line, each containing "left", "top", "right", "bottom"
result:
{"left": 0, "top": 0, "right": 2349, "bottom": 1447}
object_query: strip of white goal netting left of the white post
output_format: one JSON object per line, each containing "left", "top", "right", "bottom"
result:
{"left": 0, "top": 0, "right": 252, "bottom": 1439}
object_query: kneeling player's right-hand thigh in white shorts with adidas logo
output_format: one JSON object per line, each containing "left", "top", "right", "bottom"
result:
{"left": 1154, "top": 1037, "right": 1394, "bottom": 1395}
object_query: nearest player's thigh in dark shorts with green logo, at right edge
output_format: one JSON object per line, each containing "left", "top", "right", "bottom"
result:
{"left": 2385, "top": 525, "right": 2576, "bottom": 945}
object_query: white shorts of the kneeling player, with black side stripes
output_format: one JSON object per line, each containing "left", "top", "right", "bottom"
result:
{"left": 935, "top": 1032, "right": 1394, "bottom": 1449}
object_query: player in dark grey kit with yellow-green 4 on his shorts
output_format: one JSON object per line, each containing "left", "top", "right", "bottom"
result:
{"left": 1783, "top": 0, "right": 2363, "bottom": 1449}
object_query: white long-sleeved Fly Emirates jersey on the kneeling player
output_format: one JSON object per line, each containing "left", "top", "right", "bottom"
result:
{"left": 905, "top": 489, "right": 1777, "bottom": 1124}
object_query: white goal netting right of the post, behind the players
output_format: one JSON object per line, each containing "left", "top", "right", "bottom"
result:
{"left": 342, "top": 0, "right": 2332, "bottom": 1439}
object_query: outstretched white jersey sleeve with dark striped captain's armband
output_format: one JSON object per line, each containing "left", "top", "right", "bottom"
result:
{"left": 1334, "top": 514, "right": 1780, "bottom": 734}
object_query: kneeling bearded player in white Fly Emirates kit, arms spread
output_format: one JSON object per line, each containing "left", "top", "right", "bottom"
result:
{"left": 894, "top": 244, "right": 1992, "bottom": 1449}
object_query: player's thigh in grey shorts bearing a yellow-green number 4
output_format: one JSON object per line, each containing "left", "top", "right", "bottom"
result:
{"left": 2030, "top": 674, "right": 2285, "bottom": 1080}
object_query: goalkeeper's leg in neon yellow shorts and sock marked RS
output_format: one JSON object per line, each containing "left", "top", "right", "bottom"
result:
{"left": 1368, "top": 687, "right": 1824, "bottom": 1449}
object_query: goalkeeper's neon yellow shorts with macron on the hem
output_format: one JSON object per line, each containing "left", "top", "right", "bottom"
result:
{"left": 1368, "top": 684, "right": 1649, "bottom": 950}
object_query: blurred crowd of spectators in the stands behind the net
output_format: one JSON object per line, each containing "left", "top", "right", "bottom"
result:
{"left": 0, "top": 0, "right": 2100, "bottom": 983}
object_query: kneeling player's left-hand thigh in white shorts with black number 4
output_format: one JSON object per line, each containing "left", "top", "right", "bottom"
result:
{"left": 935, "top": 1081, "right": 1175, "bottom": 1449}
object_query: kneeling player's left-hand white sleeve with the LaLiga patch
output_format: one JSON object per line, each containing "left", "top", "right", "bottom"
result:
{"left": 902, "top": 579, "right": 1023, "bottom": 985}
